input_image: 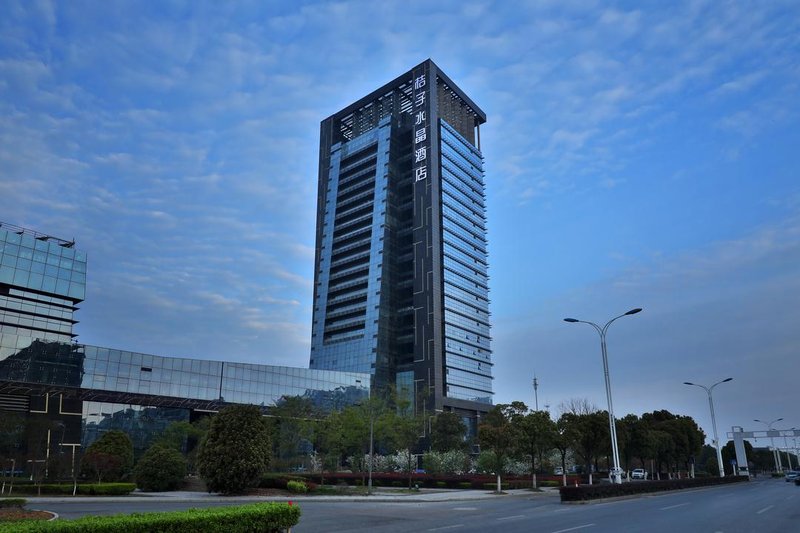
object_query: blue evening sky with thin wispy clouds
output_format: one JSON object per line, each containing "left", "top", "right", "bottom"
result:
{"left": 0, "top": 0, "right": 800, "bottom": 444}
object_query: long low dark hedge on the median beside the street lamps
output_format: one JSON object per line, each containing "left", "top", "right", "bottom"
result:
{"left": 559, "top": 476, "right": 749, "bottom": 502}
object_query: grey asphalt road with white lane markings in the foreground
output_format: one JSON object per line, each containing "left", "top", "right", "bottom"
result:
{"left": 32, "top": 479, "right": 800, "bottom": 533}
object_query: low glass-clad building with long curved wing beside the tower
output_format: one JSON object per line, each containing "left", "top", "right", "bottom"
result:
{"left": 0, "top": 223, "right": 370, "bottom": 466}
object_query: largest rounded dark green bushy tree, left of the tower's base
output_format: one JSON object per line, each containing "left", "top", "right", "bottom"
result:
{"left": 197, "top": 405, "right": 272, "bottom": 494}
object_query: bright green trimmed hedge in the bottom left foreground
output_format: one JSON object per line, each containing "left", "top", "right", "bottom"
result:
{"left": 0, "top": 502, "right": 300, "bottom": 533}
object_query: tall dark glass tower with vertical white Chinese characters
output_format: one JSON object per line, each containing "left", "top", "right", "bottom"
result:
{"left": 310, "top": 60, "right": 492, "bottom": 418}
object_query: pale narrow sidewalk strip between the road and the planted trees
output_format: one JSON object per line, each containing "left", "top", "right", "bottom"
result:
{"left": 26, "top": 487, "right": 558, "bottom": 505}
